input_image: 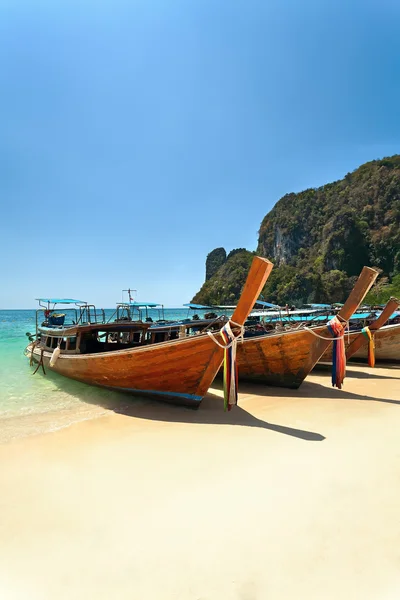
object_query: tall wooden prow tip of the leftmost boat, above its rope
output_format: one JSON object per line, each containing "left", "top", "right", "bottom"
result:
{"left": 232, "top": 256, "right": 274, "bottom": 325}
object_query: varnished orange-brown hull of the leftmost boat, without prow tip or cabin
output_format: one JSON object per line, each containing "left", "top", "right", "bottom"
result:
{"left": 27, "top": 335, "right": 222, "bottom": 406}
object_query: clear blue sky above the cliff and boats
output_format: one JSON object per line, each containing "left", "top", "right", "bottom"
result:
{"left": 0, "top": 0, "right": 400, "bottom": 308}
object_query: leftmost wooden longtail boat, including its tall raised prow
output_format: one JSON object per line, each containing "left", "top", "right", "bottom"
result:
{"left": 26, "top": 257, "right": 273, "bottom": 406}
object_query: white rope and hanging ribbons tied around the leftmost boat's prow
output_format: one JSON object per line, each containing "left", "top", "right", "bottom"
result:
{"left": 207, "top": 321, "right": 244, "bottom": 410}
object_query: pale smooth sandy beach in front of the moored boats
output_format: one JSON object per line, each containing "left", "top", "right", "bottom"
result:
{"left": 0, "top": 365, "right": 400, "bottom": 600}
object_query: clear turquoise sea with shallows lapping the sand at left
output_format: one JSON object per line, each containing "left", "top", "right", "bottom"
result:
{"left": 0, "top": 308, "right": 201, "bottom": 443}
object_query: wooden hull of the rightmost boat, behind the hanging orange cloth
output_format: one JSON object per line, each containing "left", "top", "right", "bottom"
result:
{"left": 321, "top": 323, "right": 400, "bottom": 363}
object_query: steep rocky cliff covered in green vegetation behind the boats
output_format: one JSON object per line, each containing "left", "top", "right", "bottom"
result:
{"left": 194, "top": 155, "right": 400, "bottom": 304}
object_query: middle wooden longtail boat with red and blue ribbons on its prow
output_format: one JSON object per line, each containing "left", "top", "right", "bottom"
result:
{"left": 237, "top": 267, "right": 378, "bottom": 389}
